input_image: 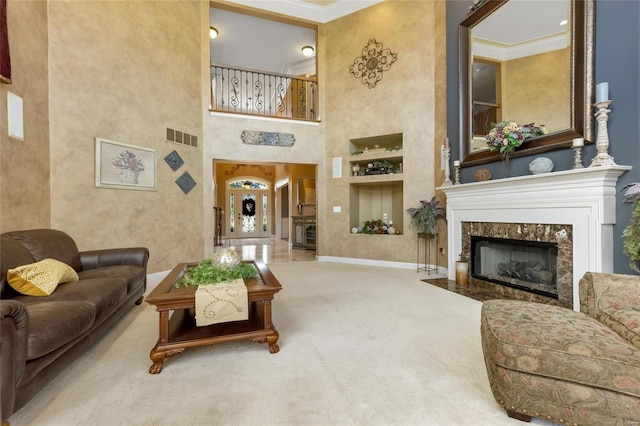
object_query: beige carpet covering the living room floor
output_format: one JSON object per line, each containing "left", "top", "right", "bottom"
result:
{"left": 10, "top": 262, "right": 545, "bottom": 426}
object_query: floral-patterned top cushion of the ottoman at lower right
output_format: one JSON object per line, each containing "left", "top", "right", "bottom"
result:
{"left": 481, "top": 300, "right": 640, "bottom": 397}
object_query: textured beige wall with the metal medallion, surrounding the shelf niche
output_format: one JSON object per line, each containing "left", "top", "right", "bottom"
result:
{"left": 319, "top": 0, "right": 446, "bottom": 263}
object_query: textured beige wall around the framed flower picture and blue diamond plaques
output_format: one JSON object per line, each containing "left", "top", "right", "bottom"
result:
{"left": 48, "top": 0, "right": 205, "bottom": 272}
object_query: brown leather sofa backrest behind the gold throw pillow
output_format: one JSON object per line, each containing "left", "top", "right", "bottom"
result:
{"left": 7, "top": 229, "right": 82, "bottom": 271}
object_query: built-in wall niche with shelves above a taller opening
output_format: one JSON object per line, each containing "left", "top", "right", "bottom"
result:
{"left": 349, "top": 133, "right": 404, "bottom": 231}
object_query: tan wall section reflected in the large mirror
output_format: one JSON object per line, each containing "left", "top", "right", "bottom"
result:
{"left": 502, "top": 48, "right": 571, "bottom": 131}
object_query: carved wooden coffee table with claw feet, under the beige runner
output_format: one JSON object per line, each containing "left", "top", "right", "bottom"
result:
{"left": 145, "top": 262, "right": 282, "bottom": 374}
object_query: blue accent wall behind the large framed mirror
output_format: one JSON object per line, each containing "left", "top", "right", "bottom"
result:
{"left": 447, "top": 0, "right": 640, "bottom": 274}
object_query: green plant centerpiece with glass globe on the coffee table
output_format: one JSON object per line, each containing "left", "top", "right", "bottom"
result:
{"left": 175, "top": 251, "right": 258, "bottom": 287}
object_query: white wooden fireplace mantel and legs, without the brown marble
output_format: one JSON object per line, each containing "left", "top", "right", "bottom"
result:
{"left": 437, "top": 165, "right": 631, "bottom": 310}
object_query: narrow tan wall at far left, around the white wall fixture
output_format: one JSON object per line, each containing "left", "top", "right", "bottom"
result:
{"left": 0, "top": 0, "right": 50, "bottom": 232}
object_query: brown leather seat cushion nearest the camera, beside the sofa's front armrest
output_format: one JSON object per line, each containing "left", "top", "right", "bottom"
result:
{"left": 27, "top": 298, "right": 95, "bottom": 360}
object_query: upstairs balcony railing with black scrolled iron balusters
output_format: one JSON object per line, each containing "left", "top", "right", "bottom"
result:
{"left": 211, "top": 64, "right": 318, "bottom": 121}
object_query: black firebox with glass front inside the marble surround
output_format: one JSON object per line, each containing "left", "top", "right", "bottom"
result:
{"left": 471, "top": 236, "right": 558, "bottom": 299}
